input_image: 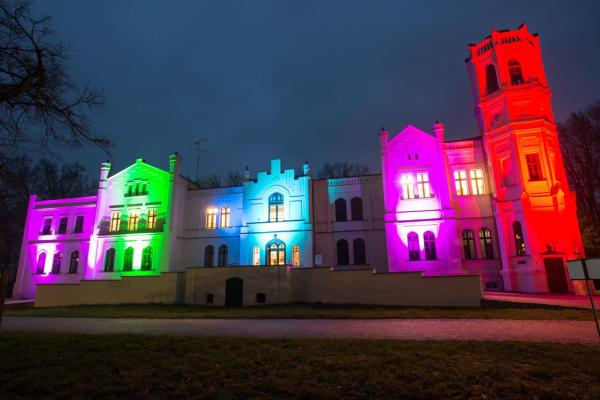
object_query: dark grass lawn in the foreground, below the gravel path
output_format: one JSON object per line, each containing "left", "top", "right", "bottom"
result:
{"left": 0, "top": 333, "right": 600, "bottom": 399}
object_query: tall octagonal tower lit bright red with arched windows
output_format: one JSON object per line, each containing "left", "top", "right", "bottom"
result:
{"left": 465, "top": 24, "right": 583, "bottom": 293}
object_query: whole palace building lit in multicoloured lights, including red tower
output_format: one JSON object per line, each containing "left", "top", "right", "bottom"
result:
{"left": 14, "top": 25, "right": 584, "bottom": 303}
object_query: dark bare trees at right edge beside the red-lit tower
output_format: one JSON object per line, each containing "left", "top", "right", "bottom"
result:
{"left": 558, "top": 101, "right": 600, "bottom": 255}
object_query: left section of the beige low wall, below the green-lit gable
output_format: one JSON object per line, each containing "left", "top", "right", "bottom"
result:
{"left": 35, "top": 272, "right": 185, "bottom": 307}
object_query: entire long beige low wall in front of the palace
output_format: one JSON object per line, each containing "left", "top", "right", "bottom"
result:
{"left": 35, "top": 266, "right": 481, "bottom": 307}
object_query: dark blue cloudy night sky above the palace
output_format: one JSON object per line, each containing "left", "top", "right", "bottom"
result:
{"left": 33, "top": 0, "right": 600, "bottom": 178}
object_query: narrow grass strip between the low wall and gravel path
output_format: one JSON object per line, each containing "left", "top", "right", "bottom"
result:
{"left": 6, "top": 301, "right": 593, "bottom": 320}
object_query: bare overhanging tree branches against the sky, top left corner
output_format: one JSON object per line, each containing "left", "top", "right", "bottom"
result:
{"left": 0, "top": 0, "right": 109, "bottom": 149}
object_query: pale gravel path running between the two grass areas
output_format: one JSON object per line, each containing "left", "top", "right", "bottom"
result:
{"left": 2, "top": 317, "right": 600, "bottom": 344}
